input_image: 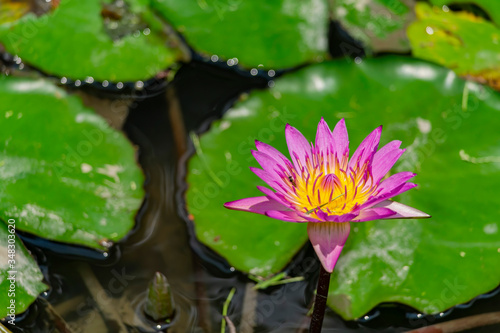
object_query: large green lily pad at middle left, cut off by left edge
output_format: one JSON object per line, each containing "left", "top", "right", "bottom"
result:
{"left": 0, "top": 77, "right": 144, "bottom": 249}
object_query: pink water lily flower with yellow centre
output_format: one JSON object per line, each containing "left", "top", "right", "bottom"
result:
{"left": 224, "top": 119, "right": 429, "bottom": 273}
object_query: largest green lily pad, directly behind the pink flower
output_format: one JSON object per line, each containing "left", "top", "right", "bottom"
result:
{"left": 187, "top": 56, "right": 500, "bottom": 319}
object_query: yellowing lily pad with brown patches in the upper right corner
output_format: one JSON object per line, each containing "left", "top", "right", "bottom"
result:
{"left": 408, "top": 3, "right": 500, "bottom": 90}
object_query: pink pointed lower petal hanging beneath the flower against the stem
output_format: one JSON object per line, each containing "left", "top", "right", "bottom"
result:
{"left": 307, "top": 222, "right": 350, "bottom": 273}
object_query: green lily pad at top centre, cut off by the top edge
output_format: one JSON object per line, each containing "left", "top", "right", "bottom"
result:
{"left": 151, "top": 0, "right": 328, "bottom": 69}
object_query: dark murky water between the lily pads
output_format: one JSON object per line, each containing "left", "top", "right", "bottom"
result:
{"left": 5, "top": 61, "right": 500, "bottom": 333}
